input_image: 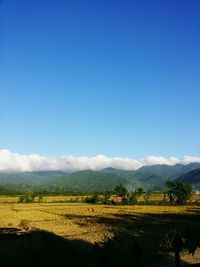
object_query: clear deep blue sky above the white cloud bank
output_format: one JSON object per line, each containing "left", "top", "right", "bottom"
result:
{"left": 0, "top": 0, "right": 200, "bottom": 158}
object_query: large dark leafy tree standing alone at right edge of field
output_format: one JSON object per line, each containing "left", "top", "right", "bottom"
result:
{"left": 166, "top": 180, "right": 192, "bottom": 205}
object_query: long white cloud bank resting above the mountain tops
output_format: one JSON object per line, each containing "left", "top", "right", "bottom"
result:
{"left": 0, "top": 149, "right": 200, "bottom": 172}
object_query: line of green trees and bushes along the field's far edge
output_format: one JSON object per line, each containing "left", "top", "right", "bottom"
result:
{"left": 0, "top": 180, "right": 192, "bottom": 205}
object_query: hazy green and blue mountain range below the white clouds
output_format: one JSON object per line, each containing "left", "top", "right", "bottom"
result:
{"left": 0, "top": 163, "right": 200, "bottom": 192}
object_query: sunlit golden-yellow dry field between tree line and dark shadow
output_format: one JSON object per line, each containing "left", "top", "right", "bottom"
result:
{"left": 0, "top": 203, "right": 200, "bottom": 243}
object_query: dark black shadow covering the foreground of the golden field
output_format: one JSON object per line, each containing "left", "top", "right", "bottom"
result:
{"left": 0, "top": 210, "right": 200, "bottom": 267}
